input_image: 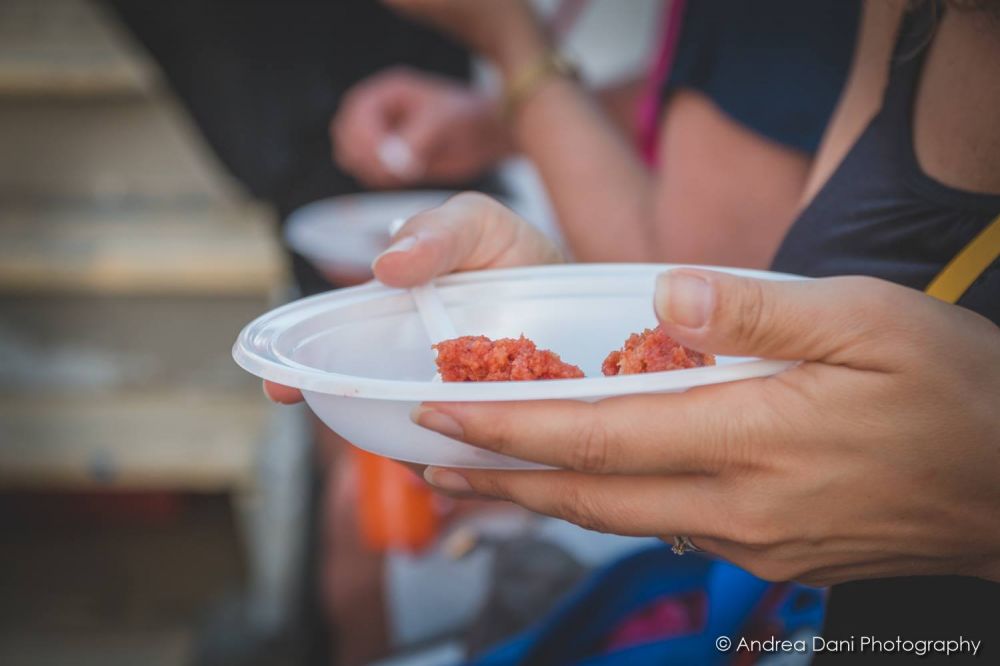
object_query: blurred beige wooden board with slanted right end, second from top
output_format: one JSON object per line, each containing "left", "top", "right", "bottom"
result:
{"left": 0, "top": 96, "right": 245, "bottom": 205}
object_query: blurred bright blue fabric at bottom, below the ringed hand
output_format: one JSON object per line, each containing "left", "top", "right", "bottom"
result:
{"left": 471, "top": 547, "right": 824, "bottom": 666}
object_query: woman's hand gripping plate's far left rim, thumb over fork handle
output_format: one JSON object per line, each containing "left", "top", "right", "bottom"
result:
{"left": 264, "top": 192, "right": 562, "bottom": 404}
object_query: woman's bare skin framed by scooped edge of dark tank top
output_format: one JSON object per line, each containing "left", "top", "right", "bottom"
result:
{"left": 913, "top": 9, "right": 1000, "bottom": 194}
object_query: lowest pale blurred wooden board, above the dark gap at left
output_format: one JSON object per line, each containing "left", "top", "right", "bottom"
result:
{"left": 0, "top": 391, "right": 270, "bottom": 492}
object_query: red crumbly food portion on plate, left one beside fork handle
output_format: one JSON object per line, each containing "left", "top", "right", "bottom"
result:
{"left": 434, "top": 335, "right": 583, "bottom": 382}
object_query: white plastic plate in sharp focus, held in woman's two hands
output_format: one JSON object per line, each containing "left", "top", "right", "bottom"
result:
{"left": 233, "top": 264, "right": 803, "bottom": 469}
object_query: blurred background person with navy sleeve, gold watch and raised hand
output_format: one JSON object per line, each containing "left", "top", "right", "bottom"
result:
{"left": 331, "top": 0, "right": 860, "bottom": 267}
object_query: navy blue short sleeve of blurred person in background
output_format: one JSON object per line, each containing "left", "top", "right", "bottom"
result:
{"left": 664, "top": 0, "right": 861, "bottom": 153}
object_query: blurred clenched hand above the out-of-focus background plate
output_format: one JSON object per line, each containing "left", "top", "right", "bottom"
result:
{"left": 330, "top": 68, "right": 508, "bottom": 187}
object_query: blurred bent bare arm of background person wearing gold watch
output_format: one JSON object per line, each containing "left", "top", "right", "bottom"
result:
{"left": 386, "top": 0, "right": 810, "bottom": 267}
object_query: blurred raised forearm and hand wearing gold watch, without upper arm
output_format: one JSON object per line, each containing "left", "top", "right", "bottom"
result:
{"left": 390, "top": 0, "right": 653, "bottom": 261}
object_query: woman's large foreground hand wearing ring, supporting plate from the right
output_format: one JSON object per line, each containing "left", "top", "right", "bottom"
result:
{"left": 414, "top": 269, "right": 1000, "bottom": 585}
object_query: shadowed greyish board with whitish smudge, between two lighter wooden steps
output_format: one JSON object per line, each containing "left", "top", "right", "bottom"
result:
{"left": 0, "top": 294, "right": 273, "bottom": 395}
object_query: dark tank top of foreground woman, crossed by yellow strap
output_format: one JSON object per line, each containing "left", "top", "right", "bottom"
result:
{"left": 772, "top": 2, "right": 1000, "bottom": 323}
